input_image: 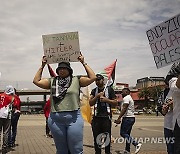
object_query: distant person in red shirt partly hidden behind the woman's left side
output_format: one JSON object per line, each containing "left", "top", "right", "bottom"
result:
{"left": 44, "top": 99, "right": 52, "bottom": 138}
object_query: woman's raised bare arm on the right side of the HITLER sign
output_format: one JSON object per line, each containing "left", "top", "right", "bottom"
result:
{"left": 78, "top": 55, "right": 96, "bottom": 87}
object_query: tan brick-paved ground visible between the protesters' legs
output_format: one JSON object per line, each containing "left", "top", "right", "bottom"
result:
{"left": 1, "top": 115, "right": 166, "bottom": 154}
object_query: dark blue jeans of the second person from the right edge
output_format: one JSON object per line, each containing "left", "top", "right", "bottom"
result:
{"left": 164, "top": 128, "right": 174, "bottom": 154}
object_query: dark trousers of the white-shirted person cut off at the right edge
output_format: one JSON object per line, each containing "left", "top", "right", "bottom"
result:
{"left": 174, "top": 121, "right": 180, "bottom": 154}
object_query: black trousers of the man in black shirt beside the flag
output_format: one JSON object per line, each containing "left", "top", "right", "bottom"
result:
{"left": 92, "top": 117, "right": 112, "bottom": 154}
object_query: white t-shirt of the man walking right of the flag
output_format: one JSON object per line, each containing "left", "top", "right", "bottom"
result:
{"left": 122, "top": 95, "right": 135, "bottom": 117}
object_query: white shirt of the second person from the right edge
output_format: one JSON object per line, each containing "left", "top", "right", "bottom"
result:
{"left": 164, "top": 90, "right": 173, "bottom": 130}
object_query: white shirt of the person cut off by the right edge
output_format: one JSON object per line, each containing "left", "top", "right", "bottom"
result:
{"left": 169, "top": 77, "right": 180, "bottom": 129}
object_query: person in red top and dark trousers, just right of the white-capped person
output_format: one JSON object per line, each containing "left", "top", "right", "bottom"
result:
{"left": 8, "top": 89, "right": 21, "bottom": 147}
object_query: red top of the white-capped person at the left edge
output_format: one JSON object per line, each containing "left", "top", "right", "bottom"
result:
{"left": 0, "top": 93, "right": 13, "bottom": 108}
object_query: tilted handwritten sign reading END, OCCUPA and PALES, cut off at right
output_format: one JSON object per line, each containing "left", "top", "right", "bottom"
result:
{"left": 146, "top": 14, "right": 180, "bottom": 68}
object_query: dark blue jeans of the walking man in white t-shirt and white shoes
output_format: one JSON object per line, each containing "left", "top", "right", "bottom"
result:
{"left": 120, "top": 117, "right": 138, "bottom": 152}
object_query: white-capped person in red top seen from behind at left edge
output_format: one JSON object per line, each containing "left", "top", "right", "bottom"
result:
{"left": 0, "top": 85, "right": 15, "bottom": 153}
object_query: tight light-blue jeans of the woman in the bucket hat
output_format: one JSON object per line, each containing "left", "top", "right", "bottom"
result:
{"left": 48, "top": 110, "right": 84, "bottom": 154}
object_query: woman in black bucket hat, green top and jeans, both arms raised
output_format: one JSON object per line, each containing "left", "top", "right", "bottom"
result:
{"left": 33, "top": 55, "right": 96, "bottom": 154}
